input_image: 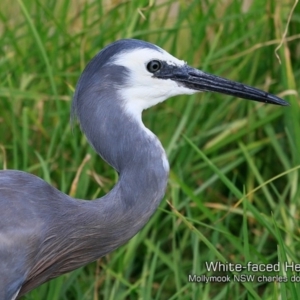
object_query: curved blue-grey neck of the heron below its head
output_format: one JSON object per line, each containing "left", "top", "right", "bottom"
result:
{"left": 74, "top": 102, "right": 169, "bottom": 260}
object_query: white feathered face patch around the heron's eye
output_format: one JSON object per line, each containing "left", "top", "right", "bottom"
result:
{"left": 114, "top": 48, "right": 196, "bottom": 121}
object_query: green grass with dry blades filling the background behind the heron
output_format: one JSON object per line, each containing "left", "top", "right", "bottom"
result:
{"left": 0, "top": 0, "right": 300, "bottom": 300}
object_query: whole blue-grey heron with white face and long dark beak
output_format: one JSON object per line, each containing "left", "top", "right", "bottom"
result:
{"left": 0, "top": 39, "right": 287, "bottom": 300}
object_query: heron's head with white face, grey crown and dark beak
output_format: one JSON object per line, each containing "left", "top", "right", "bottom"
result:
{"left": 72, "top": 39, "right": 288, "bottom": 122}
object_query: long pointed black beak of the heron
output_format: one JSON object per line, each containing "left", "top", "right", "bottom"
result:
{"left": 155, "top": 65, "right": 289, "bottom": 106}
